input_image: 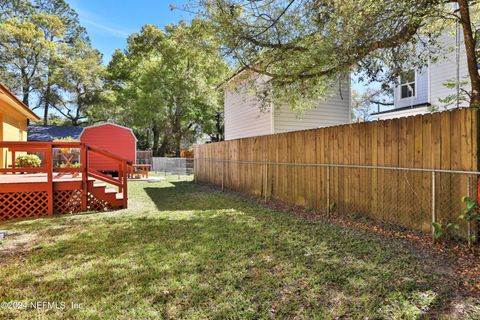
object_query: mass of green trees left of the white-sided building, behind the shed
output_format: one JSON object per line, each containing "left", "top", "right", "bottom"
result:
{"left": 0, "top": 0, "right": 227, "bottom": 150}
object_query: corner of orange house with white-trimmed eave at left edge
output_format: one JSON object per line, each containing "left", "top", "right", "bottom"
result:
{"left": 0, "top": 82, "right": 40, "bottom": 168}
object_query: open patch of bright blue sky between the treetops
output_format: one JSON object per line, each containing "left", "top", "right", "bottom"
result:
{"left": 67, "top": 0, "right": 189, "bottom": 64}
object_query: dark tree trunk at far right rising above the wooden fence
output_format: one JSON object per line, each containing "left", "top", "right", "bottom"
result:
{"left": 458, "top": 0, "right": 480, "bottom": 107}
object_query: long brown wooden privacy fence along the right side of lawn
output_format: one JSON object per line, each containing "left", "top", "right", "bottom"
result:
{"left": 195, "top": 109, "right": 478, "bottom": 238}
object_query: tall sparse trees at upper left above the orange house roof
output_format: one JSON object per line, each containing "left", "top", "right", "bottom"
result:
{"left": 0, "top": 0, "right": 102, "bottom": 124}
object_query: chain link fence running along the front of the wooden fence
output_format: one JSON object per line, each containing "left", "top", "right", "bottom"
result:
{"left": 195, "top": 158, "right": 480, "bottom": 239}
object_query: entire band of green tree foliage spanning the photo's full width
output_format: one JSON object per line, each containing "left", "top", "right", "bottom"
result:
{"left": 0, "top": 0, "right": 480, "bottom": 150}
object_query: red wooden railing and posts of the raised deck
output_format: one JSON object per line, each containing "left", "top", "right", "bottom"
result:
{"left": 0, "top": 142, "right": 131, "bottom": 214}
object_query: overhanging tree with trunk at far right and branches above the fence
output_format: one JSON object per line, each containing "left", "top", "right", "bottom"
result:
{"left": 199, "top": 0, "right": 480, "bottom": 105}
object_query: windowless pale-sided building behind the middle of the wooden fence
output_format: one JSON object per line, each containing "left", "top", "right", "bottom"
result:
{"left": 224, "top": 73, "right": 351, "bottom": 140}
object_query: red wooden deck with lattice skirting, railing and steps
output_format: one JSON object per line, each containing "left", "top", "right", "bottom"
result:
{"left": 0, "top": 141, "right": 132, "bottom": 220}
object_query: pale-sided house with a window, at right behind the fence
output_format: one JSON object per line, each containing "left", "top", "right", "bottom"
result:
{"left": 372, "top": 27, "right": 469, "bottom": 120}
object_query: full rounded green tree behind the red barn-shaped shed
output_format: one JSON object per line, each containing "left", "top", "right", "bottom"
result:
{"left": 108, "top": 20, "right": 227, "bottom": 155}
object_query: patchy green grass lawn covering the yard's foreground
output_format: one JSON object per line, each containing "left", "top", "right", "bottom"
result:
{"left": 0, "top": 176, "right": 480, "bottom": 319}
